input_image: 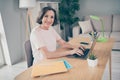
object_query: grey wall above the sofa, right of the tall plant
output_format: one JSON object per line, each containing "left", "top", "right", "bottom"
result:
{"left": 77, "top": 0, "right": 120, "bottom": 18}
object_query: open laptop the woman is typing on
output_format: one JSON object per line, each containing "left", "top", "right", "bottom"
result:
{"left": 68, "top": 35, "right": 99, "bottom": 59}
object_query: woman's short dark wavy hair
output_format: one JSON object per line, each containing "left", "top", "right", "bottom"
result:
{"left": 37, "top": 6, "right": 58, "bottom": 26}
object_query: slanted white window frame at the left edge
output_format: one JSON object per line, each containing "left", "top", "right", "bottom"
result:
{"left": 0, "top": 13, "right": 11, "bottom": 65}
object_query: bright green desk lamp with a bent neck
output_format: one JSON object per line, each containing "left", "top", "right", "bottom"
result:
{"left": 90, "top": 15, "right": 107, "bottom": 42}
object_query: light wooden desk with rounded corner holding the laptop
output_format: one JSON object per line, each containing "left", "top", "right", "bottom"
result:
{"left": 15, "top": 38, "right": 114, "bottom": 80}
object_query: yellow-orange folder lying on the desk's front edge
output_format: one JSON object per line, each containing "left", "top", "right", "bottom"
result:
{"left": 31, "top": 61, "right": 68, "bottom": 77}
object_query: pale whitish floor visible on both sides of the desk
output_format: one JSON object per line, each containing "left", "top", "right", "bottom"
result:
{"left": 0, "top": 51, "right": 120, "bottom": 80}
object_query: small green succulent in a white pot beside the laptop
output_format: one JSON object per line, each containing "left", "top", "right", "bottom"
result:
{"left": 87, "top": 53, "right": 98, "bottom": 67}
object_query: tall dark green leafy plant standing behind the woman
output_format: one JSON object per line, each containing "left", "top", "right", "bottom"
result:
{"left": 59, "top": 0, "right": 80, "bottom": 40}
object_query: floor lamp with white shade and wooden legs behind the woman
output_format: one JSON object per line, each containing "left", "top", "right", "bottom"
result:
{"left": 19, "top": 0, "right": 36, "bottom": 38}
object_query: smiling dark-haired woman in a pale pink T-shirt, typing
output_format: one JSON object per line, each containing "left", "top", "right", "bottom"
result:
{"left": 30, "top": 7, "right": 83, "bottom": 63}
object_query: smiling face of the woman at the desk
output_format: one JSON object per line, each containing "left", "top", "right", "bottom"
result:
{"left": 42, "top": 10, "right": 55, "bottom": 29}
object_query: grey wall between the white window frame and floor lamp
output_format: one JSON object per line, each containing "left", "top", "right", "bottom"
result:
{"left": 0, "top": 0, "right": 25, "bottom": 64}
